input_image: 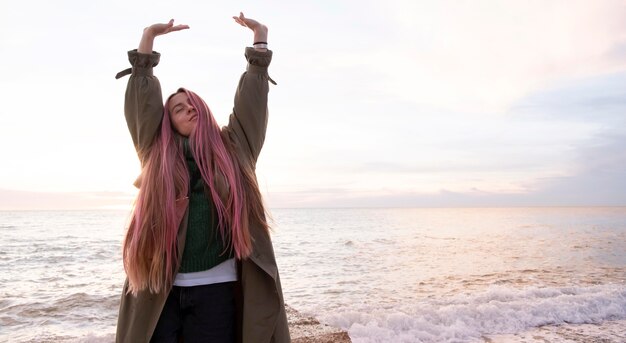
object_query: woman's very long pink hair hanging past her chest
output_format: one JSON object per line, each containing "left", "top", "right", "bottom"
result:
{"left": 123, "top": 88, "right": 269, "bottom": 294}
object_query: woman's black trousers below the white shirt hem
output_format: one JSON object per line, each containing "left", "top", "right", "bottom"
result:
{"left": 150, "top": 282, "right": 236, "bottom": 343}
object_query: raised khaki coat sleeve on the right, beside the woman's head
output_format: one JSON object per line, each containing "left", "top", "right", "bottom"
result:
{"left": 227, "top": 48, "right": 272, "bottom": 161}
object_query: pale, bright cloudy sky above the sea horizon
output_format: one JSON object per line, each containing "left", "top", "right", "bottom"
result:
{"left": 0, "top": 0, "right": 626, "bottom": 210}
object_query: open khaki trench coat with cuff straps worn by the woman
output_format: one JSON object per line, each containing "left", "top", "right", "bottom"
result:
{"left": 116, "top": 48, "right": 291, "bottom": 343}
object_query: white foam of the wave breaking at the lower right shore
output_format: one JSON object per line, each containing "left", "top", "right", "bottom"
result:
{"left": 323, "top": 285, "right": 626, "bottom": 343}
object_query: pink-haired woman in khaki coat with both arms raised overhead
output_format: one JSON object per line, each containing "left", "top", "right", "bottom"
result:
{"left": 116, "top": 13, "right": 290, "bottom": 343}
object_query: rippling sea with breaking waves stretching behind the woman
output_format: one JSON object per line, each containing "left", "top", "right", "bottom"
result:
{"left": 0, "top": 207, "right": 626, "bottom": 343}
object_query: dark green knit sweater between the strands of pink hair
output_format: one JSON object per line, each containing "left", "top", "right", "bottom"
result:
{"left": 178, "top": 139, "right": 233, "bottom": 273}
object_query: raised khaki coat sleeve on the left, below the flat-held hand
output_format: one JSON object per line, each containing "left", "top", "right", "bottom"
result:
{"left": 124, "top": 50, "right": 163, "bottom": 165}
